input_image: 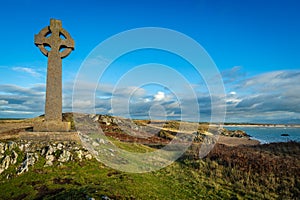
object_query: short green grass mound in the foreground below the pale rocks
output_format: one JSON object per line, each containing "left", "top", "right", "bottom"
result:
{"left": 0, "top": 160, "right": 239, "bottom": 199}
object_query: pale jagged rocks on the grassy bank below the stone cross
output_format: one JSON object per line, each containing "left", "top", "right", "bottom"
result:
{"left": 0, "top": 140, "right": 93, "bottom": 175}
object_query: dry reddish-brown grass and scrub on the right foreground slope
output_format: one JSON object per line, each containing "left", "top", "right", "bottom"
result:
{"left": 181, "top": 142, "right": 300, "bottom": 199}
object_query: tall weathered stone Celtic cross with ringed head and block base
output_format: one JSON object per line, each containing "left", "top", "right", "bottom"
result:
{"left": 34, "top": 19, "right": 74, "bottom": 131}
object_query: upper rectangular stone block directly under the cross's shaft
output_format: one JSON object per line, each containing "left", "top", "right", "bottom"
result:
{"left": 33, "top": 121, "right": 71, "bottom": 132}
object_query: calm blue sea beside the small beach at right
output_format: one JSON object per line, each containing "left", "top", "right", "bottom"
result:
{"left": 224, "top": 126, "right": 300, "bottom": 143}
